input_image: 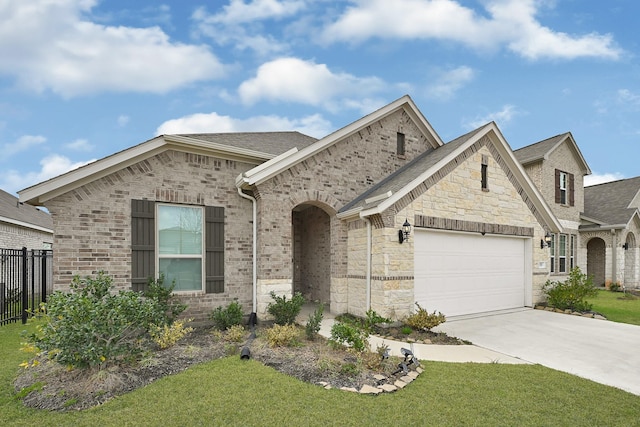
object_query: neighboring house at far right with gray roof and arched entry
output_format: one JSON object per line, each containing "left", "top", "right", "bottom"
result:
{"left": 580, "top": 177, "right": 640, "bottom": 288}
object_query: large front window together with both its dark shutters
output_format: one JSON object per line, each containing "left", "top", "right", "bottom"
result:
{"left": 131, "top": 200, "right": 225, "bottom": 293}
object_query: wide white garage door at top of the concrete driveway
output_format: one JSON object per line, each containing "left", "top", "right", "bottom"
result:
{"left": 414, "top": 230, "right": 529, "bottom": 316}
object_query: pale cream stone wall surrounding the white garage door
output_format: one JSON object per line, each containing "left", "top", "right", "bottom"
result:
{"left": 349, "top": 138, "right": 549, "bottom": 318}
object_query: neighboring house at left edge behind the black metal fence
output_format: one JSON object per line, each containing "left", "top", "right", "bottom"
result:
{"left": 0, "top": 190, "right": 53, "bottom": 249}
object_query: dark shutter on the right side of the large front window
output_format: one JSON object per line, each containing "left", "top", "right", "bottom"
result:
{"left": 205, "top": 206, "right": 224, "bottom": 294}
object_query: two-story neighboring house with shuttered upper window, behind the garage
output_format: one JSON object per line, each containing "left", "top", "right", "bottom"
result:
{"left": 514, "top": 132, "right": 591, "bottom": 281}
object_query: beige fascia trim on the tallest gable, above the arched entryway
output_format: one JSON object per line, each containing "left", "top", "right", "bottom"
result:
{"left": 243, "top": 95, "right": 444, "bottom": 185}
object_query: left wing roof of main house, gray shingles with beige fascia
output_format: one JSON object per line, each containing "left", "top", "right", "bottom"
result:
{"left": 18, "top": 132, "right": 316, "bottom": 205}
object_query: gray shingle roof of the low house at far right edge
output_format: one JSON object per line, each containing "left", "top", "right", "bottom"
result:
{"left": 584, "top": 176, "right": 640, "bottom": 225}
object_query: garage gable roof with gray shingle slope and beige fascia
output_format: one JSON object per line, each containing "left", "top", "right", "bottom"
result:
{"left": 339, "top": 122, "right": 561, "bottom": 232}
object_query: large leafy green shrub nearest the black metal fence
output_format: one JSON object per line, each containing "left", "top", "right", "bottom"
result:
{"left": 27, "top": 271, "right": 179, "bottom": 367}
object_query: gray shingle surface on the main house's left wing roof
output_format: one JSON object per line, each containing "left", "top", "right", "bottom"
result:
{"left": 180, "top": 132, "right": 317, "bottom": 156}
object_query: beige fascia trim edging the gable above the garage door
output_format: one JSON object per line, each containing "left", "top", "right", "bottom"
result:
{"left": 360, "top": 122, "right": 562, "bottom": 232}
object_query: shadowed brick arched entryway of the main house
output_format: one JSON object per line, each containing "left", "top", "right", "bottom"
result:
{"left": 291, "top": 203, "right": 331, "bottom": 306}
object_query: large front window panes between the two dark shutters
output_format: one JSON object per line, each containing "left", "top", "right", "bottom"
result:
{"left": 157, "top": 204, "right": 204, "bottom": 291}
